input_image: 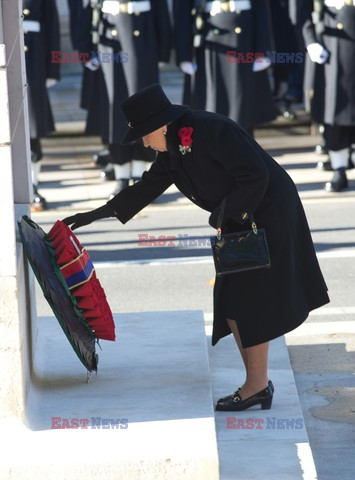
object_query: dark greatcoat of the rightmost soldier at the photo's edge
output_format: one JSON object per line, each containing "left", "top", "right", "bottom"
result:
{"left": 297, "top": 0, "right": 355, "bottom": 126}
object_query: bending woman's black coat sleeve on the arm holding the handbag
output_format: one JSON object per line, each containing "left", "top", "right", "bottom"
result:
{"left": 206, "top": 125, "right": 269, "bottom": 224}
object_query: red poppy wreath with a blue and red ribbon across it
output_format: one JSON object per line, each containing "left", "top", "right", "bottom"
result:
{"left": 46, "top": 220, "right": 116, "bottom": 340}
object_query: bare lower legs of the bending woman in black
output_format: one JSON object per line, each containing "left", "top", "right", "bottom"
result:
{"left": 227, "top": 318, "right": 269, "bottom": 400}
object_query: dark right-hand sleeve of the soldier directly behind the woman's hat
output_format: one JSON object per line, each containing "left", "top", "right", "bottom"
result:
{"left": 152, "top": 0, "right": 172, "bottom": 63}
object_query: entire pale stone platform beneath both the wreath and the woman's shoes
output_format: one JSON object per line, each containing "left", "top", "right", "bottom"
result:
{"left": 0, "top": 311, "right": 317, "bottom": 480}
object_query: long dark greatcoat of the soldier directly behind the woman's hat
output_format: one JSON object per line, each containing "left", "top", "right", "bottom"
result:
{"left": 74, "top": 0, "right": 172, "bottom": 164}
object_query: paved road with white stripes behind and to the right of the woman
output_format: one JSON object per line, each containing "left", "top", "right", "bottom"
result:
{"left": 28, "top": 69, "right": 355, "bottom": 480}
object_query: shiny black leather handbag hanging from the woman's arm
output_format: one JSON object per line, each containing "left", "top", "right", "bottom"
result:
{"left": 211, "top": 198, "right": 271, "bottom": 277}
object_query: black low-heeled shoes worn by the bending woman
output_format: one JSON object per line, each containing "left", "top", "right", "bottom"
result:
{"left": 216, "top": 380, "right": 274, "bottom": 412}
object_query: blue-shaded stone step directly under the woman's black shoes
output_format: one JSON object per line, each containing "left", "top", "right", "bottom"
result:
{"left": 206, "top": 326, "right": 317, "bottom": 480}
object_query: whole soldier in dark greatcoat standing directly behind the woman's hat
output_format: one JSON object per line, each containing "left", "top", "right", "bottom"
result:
{"left": 75, "top": 0, "right": 171, "bottom": 197}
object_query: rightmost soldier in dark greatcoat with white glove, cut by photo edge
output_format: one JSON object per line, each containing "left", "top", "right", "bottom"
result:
{"left": 297, "top": 0, "right": 355, "bottom": 192}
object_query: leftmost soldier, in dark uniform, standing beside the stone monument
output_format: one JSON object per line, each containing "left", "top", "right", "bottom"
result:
{"left": 22, "top": 0, "right": 60, "bottom": 210}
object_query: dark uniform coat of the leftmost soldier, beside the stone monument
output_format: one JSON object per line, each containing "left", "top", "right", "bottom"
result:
{"left": 22, "top": 0, "right": 60, "bottom": 138}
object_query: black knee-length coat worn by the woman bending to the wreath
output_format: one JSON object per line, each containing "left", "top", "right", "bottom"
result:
{"left": 108, "top": 110, "right": 329, "bottom": 347}
